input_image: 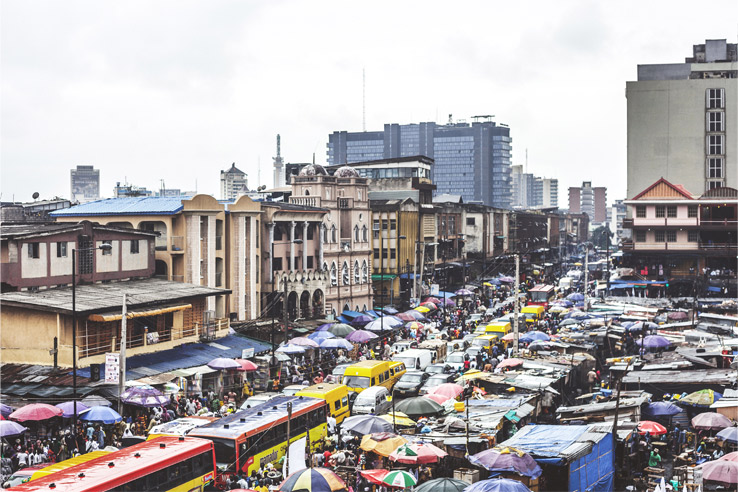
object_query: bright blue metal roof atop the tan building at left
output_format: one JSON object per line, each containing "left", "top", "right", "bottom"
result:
{"left": 49, "top": 196, "right": 190, "bottom": 217}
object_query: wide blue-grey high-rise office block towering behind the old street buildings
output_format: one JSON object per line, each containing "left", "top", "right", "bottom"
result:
{"left": 327, "top": 116, "right": 512, "bottom": 208}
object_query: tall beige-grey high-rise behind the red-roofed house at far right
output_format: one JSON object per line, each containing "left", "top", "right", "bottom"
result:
{"left": 626, "top": 39, "right": 738, "bottom": 198}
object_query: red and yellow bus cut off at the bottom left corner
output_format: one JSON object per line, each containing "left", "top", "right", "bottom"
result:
{"left": 9, "top": 436, "right": 215, "bottom": 492}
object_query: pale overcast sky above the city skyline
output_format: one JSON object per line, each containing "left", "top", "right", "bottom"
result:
{"left": 0, "top": 0, "right": 738, "bottom": 207}
